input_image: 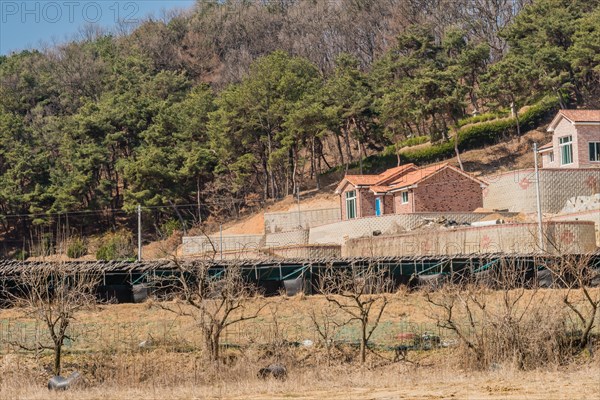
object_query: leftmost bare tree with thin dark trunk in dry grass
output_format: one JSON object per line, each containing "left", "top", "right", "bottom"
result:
{"left": 2, "top": 263, "right": 99, "bottom": 375}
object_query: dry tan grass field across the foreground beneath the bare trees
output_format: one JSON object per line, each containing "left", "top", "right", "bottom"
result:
{"left": 0, "top": 289, "right": 600, "bottom": 400}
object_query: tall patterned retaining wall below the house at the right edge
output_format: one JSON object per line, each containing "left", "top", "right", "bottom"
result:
{"left": 483, "top": 168, "right": 600, "bottom": 214}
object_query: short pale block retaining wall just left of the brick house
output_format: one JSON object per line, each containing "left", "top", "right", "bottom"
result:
{"left": 265, "top": 207, "right": 341, "bottom": 233}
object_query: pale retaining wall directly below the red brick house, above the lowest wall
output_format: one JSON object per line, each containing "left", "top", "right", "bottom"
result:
{"left": 308, "top": 212, "right": 516, "bottom": 245}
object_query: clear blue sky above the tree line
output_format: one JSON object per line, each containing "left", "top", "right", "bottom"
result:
{"left": 0, "top": 0, "right": 195, "bottom": 55}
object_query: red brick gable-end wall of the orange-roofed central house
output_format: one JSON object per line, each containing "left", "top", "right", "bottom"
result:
{"left": 409, "top": 168, "right": 483, "bottom": 212}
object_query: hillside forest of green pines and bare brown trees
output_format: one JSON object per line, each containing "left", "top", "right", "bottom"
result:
{"left": 0, "top": 0, "right": 600, "bottom": 247}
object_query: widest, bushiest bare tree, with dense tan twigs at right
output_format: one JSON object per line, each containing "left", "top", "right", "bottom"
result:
{"left": 426, "top": 260, "right": 568, "bottom": 369}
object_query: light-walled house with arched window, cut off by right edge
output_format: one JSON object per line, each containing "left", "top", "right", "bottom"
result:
{"left": 539, "top": 110, "right": 600, "bottom": 168}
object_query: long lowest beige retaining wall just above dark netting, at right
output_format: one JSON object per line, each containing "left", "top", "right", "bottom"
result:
{"left": 342, "top": 221, "right": 596, "bottom": 257}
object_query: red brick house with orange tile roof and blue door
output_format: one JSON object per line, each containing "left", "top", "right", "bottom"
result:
{"left": 335, "top": 163, "right": 487, "bottom": 220}
